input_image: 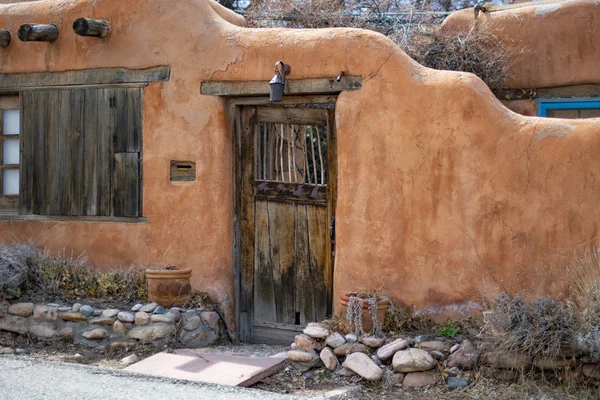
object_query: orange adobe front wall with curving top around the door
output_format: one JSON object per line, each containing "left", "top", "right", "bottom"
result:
{"left": 0, "top": 0, "right": 600, "bottom": 321}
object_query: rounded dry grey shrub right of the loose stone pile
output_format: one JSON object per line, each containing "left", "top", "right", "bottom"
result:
{"left": 483, "top": 294, "right": 579, "bottom": 363}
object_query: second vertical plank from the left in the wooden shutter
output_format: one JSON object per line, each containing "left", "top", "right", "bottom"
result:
{"left": 32, "top": 90, "right": 50, "bottom": 215}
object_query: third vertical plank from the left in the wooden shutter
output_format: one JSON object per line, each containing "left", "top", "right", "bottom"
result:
{"left": 57, "top": 90, "right": 74, "bottom": 215}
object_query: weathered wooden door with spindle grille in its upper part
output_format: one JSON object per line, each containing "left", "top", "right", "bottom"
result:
{"left": 238, "top": 106, "right": 337, "bottom": 344}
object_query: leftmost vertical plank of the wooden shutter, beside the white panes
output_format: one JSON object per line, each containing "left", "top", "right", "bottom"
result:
{"left": 19, "top": 91, "right": 35, "bottom": 214}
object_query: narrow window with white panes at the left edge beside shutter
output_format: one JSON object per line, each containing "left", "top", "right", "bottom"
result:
{"left": 0, "top": 96, "right": 21, "bottom": 208}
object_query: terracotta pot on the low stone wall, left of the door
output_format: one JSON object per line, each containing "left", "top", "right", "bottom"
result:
{"left": 146, "top": 267, "right": 192, "bottom": 307}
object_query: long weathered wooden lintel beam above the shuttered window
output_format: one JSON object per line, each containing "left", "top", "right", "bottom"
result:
{"left": 0, "top": 66, "right": 171, "bottom": 91}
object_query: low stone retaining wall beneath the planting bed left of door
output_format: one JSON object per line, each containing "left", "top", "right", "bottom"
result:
{"left": 0, "top": 302, "right": 219, "bottom": 348}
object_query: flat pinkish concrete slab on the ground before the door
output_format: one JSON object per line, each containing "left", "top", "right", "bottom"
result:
{"left": 125, "top": 350, "right": 285, "bottom": 386}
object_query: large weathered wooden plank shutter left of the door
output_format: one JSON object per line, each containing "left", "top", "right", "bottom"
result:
{"left": 20, "top": 88, "right": 142, "bottom": 217}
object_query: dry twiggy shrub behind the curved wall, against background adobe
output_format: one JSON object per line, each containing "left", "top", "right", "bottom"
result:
{"left": 408, "top": 26, "right": 522, "bottom": 88}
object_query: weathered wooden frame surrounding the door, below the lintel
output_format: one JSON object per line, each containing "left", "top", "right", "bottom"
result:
{"left": 226, "top": 95, "right": 337, "bottom": 341}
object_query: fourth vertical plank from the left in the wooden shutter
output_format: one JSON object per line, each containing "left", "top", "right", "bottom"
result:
{"left": 66, "top": 89, "right": 85, "bottom": 215}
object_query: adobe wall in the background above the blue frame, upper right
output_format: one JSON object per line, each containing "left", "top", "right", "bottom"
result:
{"left": 442, "top": 0, "right": 600, "bottom": 88}
